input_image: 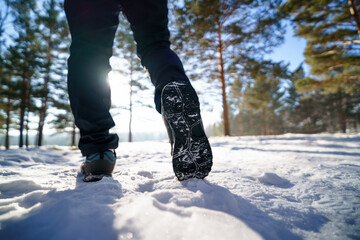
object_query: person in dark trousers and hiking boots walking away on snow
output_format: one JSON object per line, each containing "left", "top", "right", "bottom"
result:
{"left": 64, "top": 0, "right": 212, "bottom": 182}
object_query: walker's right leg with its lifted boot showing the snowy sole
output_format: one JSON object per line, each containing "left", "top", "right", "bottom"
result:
{"left": 120, "top": 0, "right": 212, "bottom": 181}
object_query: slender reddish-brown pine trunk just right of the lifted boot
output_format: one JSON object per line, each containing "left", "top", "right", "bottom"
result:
{"left": 218, "top": 30, "right": 230, "bottom": 136}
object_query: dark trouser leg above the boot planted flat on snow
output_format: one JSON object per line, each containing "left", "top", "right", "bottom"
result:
{"left": 65, "top": 0, "right": 120, "bottom": 156}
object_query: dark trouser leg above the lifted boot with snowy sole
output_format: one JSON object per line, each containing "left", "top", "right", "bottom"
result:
{"left": 119, "top": 0, "right": 190, "bottom": 113}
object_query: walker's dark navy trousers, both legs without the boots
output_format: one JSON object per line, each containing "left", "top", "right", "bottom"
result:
{"left": 65, "top": 0, "right": 189, "bottom": 156}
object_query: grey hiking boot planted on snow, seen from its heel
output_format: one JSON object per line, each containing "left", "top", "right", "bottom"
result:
{"left": 81, "top": 149, "right": 116, "bottom": 182}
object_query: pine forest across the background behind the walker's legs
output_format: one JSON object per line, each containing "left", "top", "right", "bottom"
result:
{"left": 0, "top": 0, "right": 360, "bottom": 150}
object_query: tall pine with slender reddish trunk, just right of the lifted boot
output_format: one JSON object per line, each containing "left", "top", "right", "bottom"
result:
{"left": 174, "top": 0, "right": 282, "bottom": 135}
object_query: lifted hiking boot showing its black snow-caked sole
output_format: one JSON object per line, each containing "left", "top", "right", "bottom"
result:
{"left": 161, "top": 82, "right": 212, "bottom": 181}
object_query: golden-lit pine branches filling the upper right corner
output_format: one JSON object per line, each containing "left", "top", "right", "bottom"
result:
{"left": 280, "top": 0, "right": 360, "bottom": 94}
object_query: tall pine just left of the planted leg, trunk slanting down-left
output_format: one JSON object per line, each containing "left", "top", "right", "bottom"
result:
{"left": 36, "top": 0, "right": 69, "bottom": 146}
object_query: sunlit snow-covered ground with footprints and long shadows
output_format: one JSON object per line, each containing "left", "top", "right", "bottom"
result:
{"left": 0, "top": 134, "right": 360, "bottom": 240}
